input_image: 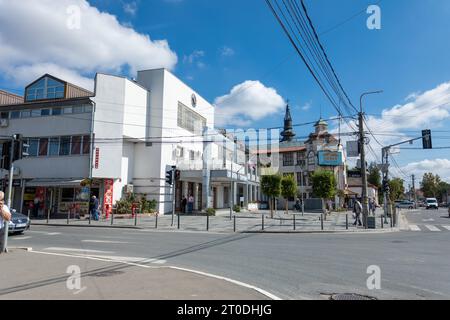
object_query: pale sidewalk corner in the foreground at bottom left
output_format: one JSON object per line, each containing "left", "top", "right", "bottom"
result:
{"left": 0, "top": 250, "right": 269, "bottom": 300}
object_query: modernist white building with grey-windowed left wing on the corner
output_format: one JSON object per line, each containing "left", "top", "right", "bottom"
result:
{"left": 0, "top": 69, "right": 259, "bottom": 215}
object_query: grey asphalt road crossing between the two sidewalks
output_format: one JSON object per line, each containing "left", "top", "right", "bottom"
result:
{"left": 9, "top": 209, "right": 450, "bottom": 299}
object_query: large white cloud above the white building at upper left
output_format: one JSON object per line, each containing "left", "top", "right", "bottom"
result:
{"left": 0, "top": 0, "right": 178, "bottom": 89}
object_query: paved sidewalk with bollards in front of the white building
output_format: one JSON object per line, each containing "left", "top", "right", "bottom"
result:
{"left": 32, "top": 210, "right": 398, "bottom": 233}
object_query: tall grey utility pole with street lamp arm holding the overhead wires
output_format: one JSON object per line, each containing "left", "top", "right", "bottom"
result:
{"left": 358, "top": 91, "right": 383, "bottom": 229}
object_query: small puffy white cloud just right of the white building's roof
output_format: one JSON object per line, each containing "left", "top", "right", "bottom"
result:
{"left": 214, "top": 81, "right": 285, "bottom": 127}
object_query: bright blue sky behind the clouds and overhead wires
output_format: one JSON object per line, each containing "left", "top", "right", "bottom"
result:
{"left": 0, "top": 0, "right": 450, "bottom": 179}
